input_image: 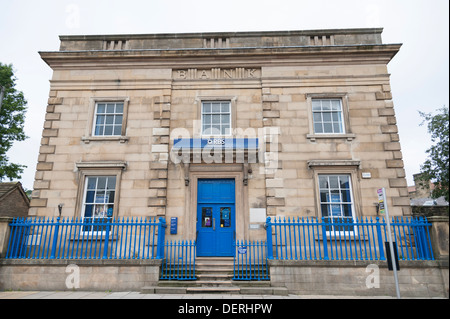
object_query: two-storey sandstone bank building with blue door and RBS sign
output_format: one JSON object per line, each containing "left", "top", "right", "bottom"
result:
{"left": 29, "top": 28, "right": 411, "bottom": 256}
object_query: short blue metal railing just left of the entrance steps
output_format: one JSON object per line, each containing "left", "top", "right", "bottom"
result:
{"left": 160, "top": 240, "right": 197, "bottom": 280}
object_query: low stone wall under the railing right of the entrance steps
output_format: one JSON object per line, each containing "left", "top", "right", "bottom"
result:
{"left": 269, "top": 259, "right": 449, "bottom": 298}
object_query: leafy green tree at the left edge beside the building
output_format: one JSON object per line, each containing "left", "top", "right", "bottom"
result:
{"left": 0, "top": 63, "right": 27, "bottom": 181}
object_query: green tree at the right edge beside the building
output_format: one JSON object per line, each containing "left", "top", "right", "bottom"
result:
{"left": 419, "top": 106, "right": 449, "bottom": 202}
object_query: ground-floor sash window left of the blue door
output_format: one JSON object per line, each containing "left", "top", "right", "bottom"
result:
{"left": 82, "top": 176, "right": 116, "bottom": 231}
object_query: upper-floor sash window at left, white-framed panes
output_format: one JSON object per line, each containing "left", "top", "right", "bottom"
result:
{"left": 92, "top": 102, "right": 123, "bottom": 136}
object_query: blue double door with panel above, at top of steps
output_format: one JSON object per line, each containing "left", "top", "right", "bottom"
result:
{"left": 197, "top": 179, "right": 236, "bottom": 256}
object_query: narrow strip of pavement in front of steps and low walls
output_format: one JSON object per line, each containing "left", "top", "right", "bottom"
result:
{"left": 0, "top": 291, "right": 445, "bottom": 300}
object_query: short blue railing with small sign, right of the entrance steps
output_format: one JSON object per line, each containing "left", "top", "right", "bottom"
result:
{"left": 233, "top": 240, "right": 270, "bottom": 280}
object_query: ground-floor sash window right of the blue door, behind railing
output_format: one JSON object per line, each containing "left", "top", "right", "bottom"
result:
{"left": 319, "top": 174, "right": 354, "bottom": 231}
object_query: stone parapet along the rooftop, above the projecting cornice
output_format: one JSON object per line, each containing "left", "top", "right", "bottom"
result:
{"left": 60, "top": 28, "right": 383, "bottom": 51}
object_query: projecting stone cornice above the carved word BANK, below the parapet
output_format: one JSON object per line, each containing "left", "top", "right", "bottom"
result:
{"left": 39, "top": 44, "right": 401, "bottom": 69}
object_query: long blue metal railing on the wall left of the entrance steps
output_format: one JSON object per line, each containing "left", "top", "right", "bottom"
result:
{"left": 5, "top": 217, "right": 166, "bottom": 259}
